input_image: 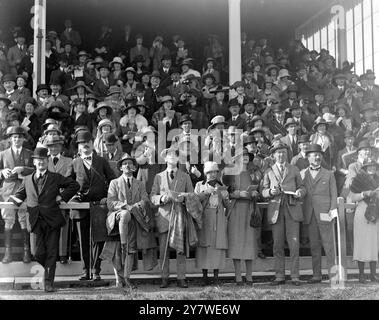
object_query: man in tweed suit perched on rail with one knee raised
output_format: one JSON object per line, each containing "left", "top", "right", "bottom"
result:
{"left": 102, "top": 153, "right": 157, "bottom": 289}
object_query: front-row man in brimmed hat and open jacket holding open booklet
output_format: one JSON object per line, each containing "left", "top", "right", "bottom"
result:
{"left": 262, "top": 140, "right": 306, "bottom": 286}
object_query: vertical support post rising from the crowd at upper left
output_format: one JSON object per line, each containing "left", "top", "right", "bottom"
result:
{"left": 32, "top": 0, "right": 46, "bottom": 97}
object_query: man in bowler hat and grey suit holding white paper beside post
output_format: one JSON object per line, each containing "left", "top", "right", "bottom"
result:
{"left": 300, "top": 144, "right": 338, "bottom": 283}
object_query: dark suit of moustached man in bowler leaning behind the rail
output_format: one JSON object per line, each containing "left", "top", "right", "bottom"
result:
{"left": 71, "top": 152, "right": 116, "bottom": 274}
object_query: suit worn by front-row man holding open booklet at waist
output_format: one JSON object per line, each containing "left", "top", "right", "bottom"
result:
{"left": 262, "top": 163, "right": 306, "bottom": 280}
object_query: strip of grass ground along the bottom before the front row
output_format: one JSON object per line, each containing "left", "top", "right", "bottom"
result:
{"left": 0, "top": 280, "right": 379, "bottom": 300}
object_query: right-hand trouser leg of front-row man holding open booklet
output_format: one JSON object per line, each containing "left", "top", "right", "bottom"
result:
{"left": 285, "top": 214, "right": 300, "bottom": 280}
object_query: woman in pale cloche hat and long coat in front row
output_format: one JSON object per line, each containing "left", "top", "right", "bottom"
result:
{"left": 195, "top": 161, "right": 229, "bottom": 286}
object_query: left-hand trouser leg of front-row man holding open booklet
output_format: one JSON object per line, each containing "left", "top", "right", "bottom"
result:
{"left": 272, "top": 210, "right": 285, "bottom": 280}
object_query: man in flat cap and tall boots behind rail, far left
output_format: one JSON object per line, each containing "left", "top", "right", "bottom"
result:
{"left": 0, "top": 126, "right": 34, "bottom": 263}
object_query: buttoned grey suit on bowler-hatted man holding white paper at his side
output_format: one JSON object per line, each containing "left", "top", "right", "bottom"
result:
{"left": 301, "top": 168, "right": 337, "bottom": 280}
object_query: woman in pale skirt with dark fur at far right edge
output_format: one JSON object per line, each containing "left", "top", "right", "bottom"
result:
{"left": 350, "top": 158, "right": 379, "bottom": 283}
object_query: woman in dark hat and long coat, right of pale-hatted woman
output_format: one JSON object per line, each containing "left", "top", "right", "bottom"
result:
{"left": 223, "top": 149, "right": 258, "bottom": 285}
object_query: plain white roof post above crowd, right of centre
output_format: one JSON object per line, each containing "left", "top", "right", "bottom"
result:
{"left": 228, "top": 0, "right": 242, "bottom": 84}
